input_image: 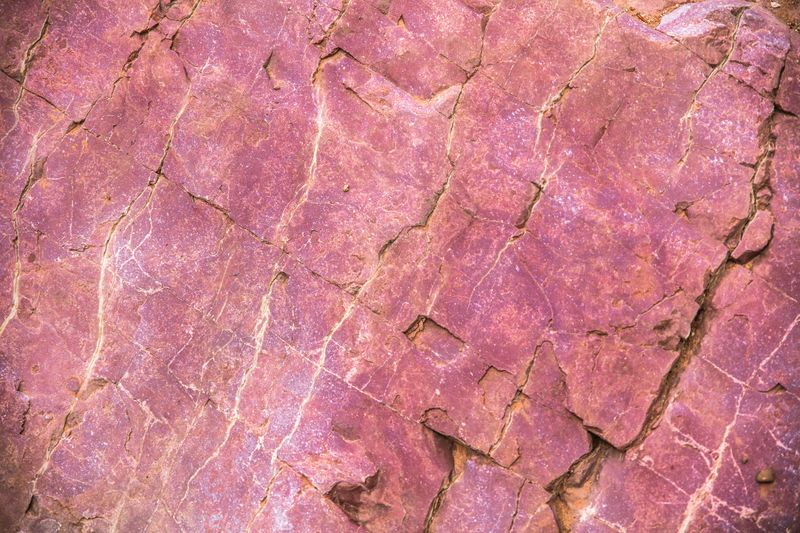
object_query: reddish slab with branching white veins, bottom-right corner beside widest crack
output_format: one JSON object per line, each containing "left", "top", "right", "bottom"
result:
{"left": 579, "top": 266, "right": 800, "bottom": 531}
